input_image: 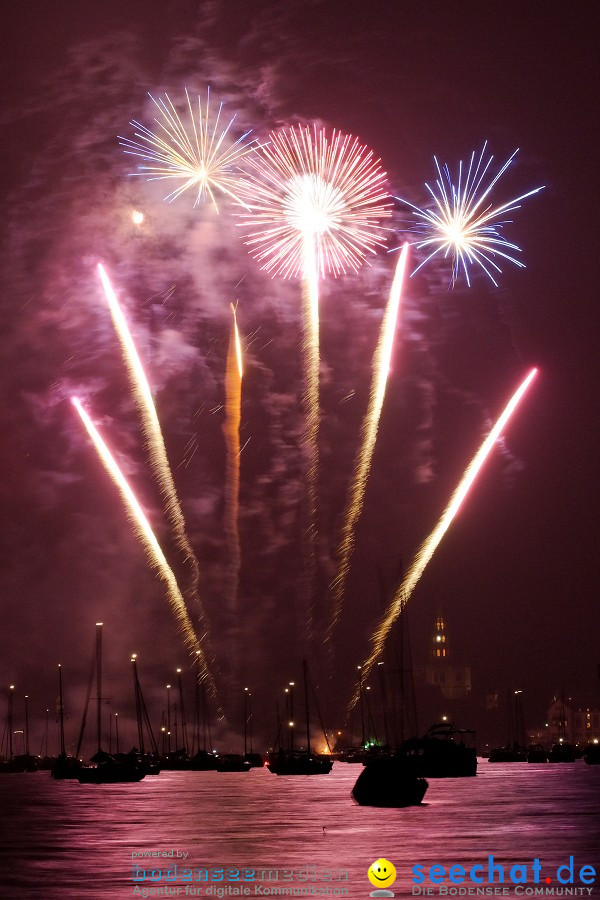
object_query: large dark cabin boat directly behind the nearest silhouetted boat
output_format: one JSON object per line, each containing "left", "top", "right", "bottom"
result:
{"left": 398, "top": 722, "right": 477, "bottom": 778}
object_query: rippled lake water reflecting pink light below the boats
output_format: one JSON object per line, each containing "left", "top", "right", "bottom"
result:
{"left": 0, "top": 760, "right": 600, "bottom": 900}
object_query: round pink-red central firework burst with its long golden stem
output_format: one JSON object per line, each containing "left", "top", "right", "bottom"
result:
{"left": 239, "top": 126, "right": 391, "bottom": 637}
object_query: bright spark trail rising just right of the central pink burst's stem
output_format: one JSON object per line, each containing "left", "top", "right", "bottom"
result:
{"left": 327, "top": 244, "right": 408, "bottom": 642}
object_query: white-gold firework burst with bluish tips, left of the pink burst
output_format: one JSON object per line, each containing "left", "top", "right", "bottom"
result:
{"left": 119, "top": 88, "right": 255, "bottom": 213}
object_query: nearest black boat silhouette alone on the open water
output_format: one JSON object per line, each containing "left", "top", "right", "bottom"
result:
{"left": 352, "top": 754, "right": 429, "bottom": 808}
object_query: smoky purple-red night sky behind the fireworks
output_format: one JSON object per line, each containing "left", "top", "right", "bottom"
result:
{"left": 0, "top": 0, "right": 600, "bottom": 752}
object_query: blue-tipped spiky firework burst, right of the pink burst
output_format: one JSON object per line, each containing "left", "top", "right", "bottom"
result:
{"left": 397, "top": 141, "right": 543, "bottom": 287}
